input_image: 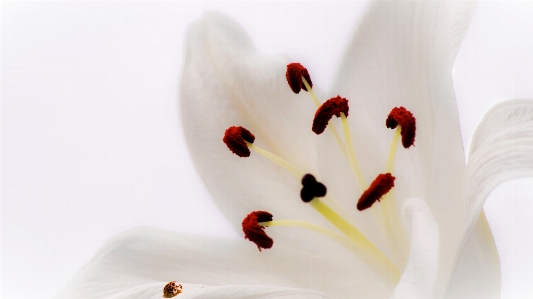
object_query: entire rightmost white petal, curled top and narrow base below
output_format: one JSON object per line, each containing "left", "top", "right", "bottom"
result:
{"left": 448, "top": 100, "right": 533, "bottom": 298}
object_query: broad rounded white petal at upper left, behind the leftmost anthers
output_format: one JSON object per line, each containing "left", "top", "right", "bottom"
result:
{"left": 180, "top": 12, "right": 328, "bottom": 248}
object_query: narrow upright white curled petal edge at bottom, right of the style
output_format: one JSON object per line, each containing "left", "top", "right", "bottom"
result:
{"left": 391, "top": 198, "right": 440, "bottom": 299}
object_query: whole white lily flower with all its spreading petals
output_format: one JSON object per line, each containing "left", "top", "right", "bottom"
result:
{"left": 54, "top": 1, "right": 533, "bottom": 299}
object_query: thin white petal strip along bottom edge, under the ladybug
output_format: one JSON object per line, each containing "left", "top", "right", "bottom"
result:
{"left": 108, "top": 282, "right": 327, "bottom": 299}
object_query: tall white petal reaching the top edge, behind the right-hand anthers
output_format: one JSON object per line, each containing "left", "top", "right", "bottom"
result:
{"left": 319, "top": 1, "right": 476, "bottom": 291}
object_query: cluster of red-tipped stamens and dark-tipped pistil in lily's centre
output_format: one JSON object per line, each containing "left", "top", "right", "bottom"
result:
{"left": 223, "top": 63, "right": 416, "bottom": 284}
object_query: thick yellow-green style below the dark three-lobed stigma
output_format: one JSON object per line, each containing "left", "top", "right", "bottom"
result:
{"left": 309, "top": 197, "right": 400, "bottom": 284}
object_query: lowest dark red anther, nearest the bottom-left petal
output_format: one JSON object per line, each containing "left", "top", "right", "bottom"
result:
{"left": 242, "top": 211, "right": 274, "bottom": 251}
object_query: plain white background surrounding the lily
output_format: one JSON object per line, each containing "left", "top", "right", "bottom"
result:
{"left": 1, "top": 2, "right": 533, "bottom": 299}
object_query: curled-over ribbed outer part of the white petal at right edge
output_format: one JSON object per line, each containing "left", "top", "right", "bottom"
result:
{"left": 464, "top": 100, "right": 533, "bottom": 230}
